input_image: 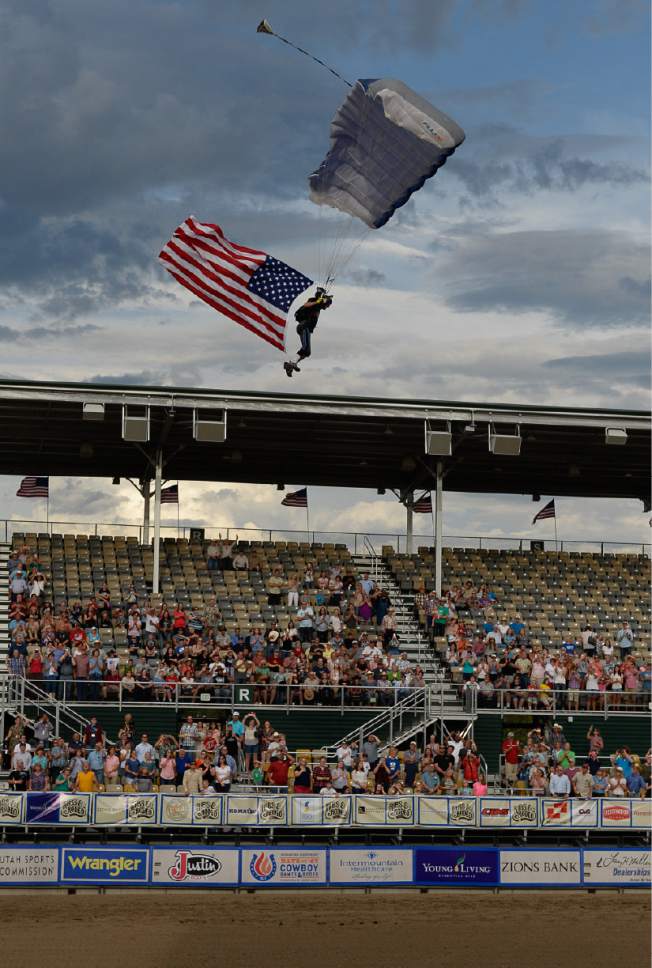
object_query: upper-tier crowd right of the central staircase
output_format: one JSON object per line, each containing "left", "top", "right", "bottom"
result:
{"left": 415, "top": 581, "right": 652, "bottom": 711}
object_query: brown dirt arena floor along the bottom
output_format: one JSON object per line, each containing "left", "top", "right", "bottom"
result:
{"left": 0, "top": 890, "right": 650, "bottom": 968}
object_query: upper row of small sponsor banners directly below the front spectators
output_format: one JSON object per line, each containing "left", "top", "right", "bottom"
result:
{"left": 0, "top": 793, "right": 652, "bottom": 830}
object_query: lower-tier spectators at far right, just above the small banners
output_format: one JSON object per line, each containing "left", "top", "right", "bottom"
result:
{"left": 502, "top": 723, "right": 652, "bottom": 800}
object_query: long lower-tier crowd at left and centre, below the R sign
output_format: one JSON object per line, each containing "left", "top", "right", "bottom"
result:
{"left": 5, "top": 711, "right": 487, "bottom": 796}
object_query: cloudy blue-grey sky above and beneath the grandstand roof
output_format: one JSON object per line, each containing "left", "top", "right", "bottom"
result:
{"left": 0, "top": 0, "right": 650, "bottom": 541}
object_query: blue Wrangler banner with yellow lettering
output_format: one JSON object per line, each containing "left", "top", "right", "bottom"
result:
{"left": 61, "top": 847, "right": 149, "bottom": 884}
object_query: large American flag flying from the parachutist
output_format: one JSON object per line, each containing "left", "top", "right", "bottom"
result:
{"left": 159, "top": 215, "right": 312, "bottom": 350}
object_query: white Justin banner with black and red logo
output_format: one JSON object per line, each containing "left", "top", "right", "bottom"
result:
{"left": 151, "top": 847, "right": 240, "bottom": 887}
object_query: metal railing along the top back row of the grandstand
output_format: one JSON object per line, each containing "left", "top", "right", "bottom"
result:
{"left": 0, "top": 518, "right": 652, "bottom": 557}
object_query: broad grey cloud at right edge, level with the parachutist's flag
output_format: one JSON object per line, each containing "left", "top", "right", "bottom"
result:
{"left": 443, "top": 229, "right": 650, "bottom": 327}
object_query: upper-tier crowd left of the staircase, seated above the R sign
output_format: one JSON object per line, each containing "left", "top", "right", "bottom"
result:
{"left": 8, "top": 542, "right": 424, "bottom": 705}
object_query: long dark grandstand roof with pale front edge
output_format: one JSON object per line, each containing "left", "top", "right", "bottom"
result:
{"left": 0, "top": 380, "right": 651, "bottom": 500}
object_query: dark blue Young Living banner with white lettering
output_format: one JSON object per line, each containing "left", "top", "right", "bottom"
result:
{"left": 414, "top": 847, "right": 500, "bottom": 887}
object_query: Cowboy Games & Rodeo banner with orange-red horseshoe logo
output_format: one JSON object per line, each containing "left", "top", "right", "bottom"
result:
{"left": 240, "top": 847, "right": 327, "bottom": 887}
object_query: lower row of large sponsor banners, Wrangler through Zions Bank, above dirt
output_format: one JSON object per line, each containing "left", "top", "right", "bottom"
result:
{"left": 0, "top": 843, "right": 650, "bottom": 890}
